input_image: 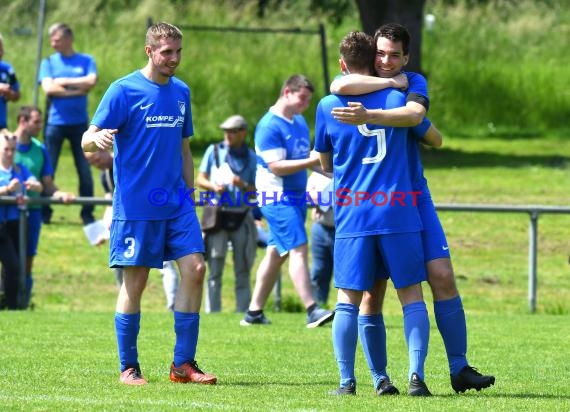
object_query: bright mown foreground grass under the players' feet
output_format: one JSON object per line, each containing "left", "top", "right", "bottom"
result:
{"left": 0, "top": 311, "right": 570, "bottom": 411}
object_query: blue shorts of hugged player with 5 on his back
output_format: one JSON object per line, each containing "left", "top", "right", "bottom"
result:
{"left": 334, "top": 232, "right": 427, "bottom": 291}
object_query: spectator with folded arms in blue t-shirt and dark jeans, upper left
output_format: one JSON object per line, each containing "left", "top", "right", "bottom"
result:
{"left": 38, "top": 23, "right": 97, "bottom": 225}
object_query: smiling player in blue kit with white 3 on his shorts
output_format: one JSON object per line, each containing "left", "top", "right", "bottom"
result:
{"left": 82, "top": 23, "right": 217, "bottom": 385}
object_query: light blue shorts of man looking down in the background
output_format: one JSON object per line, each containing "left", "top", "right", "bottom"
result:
{"left": 261, "top": 202, "right": 307, "bottom": 256}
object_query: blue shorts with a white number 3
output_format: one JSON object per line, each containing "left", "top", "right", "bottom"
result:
{"left": 109, "top": 211, "right": 204, "bottom": 269}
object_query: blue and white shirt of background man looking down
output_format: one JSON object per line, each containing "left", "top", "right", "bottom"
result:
{"left": 255, "top": 110, "right": 311, "bottom": 205}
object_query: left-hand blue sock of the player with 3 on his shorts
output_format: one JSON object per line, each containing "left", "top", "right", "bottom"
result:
{"left": 115, "top": 312, "right": 141, "bottom": 372}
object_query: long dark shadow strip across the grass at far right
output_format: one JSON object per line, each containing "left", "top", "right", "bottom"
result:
{"left": 422, "top": 148, "right": 570, "bottom": 169}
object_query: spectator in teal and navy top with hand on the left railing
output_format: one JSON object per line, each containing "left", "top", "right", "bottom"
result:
{"left": 14, "top": 106, "right": 75, "bottom": 307}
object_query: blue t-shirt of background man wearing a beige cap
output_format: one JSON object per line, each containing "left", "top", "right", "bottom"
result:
{"left": 200, "top": 142, "right": 257, "bottom": 206}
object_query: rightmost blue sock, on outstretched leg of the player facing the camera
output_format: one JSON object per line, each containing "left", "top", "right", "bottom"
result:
{"left": 433, "top": 296, "right": 467, "bottom": 375}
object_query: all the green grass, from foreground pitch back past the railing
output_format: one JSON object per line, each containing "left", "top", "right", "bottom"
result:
{"left": 0, "top": 137, "right": 570, "bottom": 411}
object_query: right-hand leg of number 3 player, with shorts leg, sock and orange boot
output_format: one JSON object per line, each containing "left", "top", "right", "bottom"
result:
{"left": 164, "top": 212, "right": 217, "bottom": 385}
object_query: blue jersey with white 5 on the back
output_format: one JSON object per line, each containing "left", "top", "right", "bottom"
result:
{"left": 315, "top": 89, "right": 422, "bottom": 238}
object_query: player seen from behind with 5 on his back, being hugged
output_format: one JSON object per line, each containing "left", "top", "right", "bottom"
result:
{"left": 315, "top": 32, "right": 431, "bottom": 396}
